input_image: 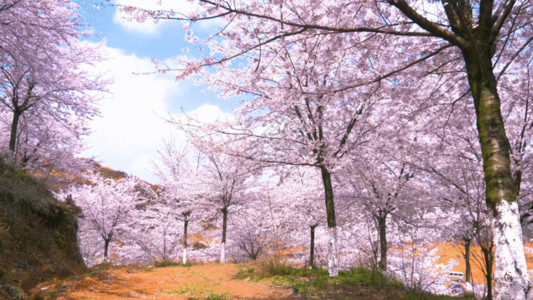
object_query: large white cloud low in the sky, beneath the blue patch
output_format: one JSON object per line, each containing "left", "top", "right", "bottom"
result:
{"left": 83, "top": 47, "right": 231, "bottom": 183}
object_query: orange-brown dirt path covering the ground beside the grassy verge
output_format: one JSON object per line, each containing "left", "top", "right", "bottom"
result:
{"left": 36, "top": 264, "right": 292, "bottom": 299}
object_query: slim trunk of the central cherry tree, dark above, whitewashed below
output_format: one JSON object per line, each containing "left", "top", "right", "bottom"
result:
{"left": 320, "top": 166, "right": 339, "bottom": 277}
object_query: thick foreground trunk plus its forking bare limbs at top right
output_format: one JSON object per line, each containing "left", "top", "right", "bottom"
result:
{"left": 388, "top": 0, "right": 531, "bottom": 300}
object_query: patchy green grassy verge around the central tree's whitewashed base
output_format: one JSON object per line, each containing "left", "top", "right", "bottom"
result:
{"left": 236, "top": 262, "right": 473, "bottom": 300}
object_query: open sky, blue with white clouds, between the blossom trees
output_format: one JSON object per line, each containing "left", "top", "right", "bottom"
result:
{"left": 77, "top": 0, "right": 239, "bottom": 183}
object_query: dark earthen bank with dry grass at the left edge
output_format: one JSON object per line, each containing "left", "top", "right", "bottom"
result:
{"left": 0, "top": 165, "right": 86, "bottom": 299}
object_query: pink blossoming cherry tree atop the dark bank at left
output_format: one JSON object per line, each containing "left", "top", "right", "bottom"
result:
{"left": 0, "top": 0, "right": 105, "bottom": 173}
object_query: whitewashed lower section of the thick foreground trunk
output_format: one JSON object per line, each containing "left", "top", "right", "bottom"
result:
{"left": 492, "top": 200, "right": 531, "bottom": 300}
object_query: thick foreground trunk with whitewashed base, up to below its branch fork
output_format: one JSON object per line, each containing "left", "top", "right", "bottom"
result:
{"left": 463, "top": 51, "right": 530, "bottom": 300}
